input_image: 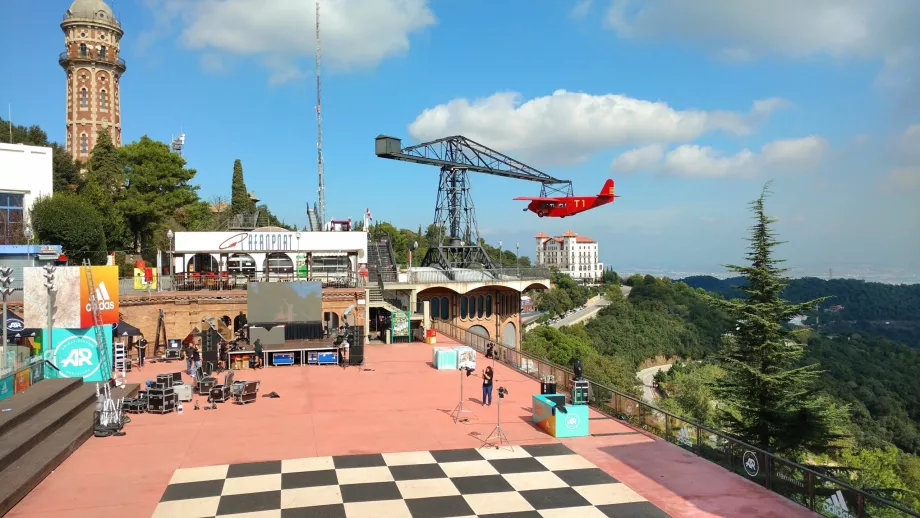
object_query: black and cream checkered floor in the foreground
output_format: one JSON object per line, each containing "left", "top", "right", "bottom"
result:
{"left": 154, "top": 444, "right": 667, "bottom": 518}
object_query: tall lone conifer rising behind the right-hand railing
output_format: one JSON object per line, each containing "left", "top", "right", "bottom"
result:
{"left": 710, "top": 183, "right": 846, "bottom": 453}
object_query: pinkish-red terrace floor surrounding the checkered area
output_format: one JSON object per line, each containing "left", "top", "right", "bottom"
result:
{"left": 8, "top": 336, "right": 816, "bottom": 518}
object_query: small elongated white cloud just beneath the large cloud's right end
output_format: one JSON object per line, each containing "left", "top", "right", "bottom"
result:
{"left": 611, "top": 136, "right": 828, "bottom": 178}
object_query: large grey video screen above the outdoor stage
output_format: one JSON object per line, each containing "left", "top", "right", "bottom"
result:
{"left": 246, "top": 281, "right": 323, "bottom": 324}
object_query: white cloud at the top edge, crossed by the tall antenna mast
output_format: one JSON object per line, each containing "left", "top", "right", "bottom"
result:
{"left": 144, "top": 0, "right": 436, "bottom": 82}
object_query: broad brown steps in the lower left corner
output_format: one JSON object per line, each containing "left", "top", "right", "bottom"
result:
{"left": 0, "top": 379, "right": 138, "bottom": 516}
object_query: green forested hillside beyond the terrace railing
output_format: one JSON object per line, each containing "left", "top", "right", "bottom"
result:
{"left": 522, "top": 191, "right": 920, "bottom": 516}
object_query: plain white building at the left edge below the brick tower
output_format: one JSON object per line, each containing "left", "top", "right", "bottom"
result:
{"left": 0, "top": 144, "right": 54, "bottom": 244}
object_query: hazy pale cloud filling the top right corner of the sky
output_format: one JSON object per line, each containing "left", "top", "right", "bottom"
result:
{"left": 606, "top": 0, "right": 920, "bottom": 93}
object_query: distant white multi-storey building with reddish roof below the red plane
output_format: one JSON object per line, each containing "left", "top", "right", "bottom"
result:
{"left": 536, "top": 230, "right": 604, "bottom": 281}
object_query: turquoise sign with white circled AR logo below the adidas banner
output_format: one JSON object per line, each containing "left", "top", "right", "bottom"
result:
{"left": 51, "top": 325, "right": 112, "bottom": 381}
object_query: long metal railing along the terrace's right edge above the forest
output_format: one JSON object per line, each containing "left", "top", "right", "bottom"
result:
{"left": 432, "top": 320, "right": 920, "bottom": 518}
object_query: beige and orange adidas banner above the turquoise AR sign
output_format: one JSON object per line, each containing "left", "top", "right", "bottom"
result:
{"left": 23, "top": 266, "right": 118, "bottom": 329}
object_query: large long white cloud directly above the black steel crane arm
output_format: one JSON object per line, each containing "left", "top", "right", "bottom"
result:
{"left": 409, "top": 90, "right": 788, "bottom": 164}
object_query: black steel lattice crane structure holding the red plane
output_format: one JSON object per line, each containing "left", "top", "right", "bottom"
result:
{"left": 375, "top": 135, "right": 572, "bottom": 271}
